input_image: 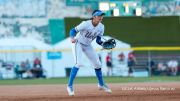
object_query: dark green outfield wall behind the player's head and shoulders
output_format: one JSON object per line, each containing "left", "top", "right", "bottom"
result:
{"left": 65, "top": 16, "right": 180, "bottom": 47}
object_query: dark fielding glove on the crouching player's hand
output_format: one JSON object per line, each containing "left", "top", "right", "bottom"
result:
{"left": 102, "top": 39, "right": 116, "bottom": 49}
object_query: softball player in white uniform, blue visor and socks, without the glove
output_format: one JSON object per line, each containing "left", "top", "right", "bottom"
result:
{"left": 67, "top": 10, "right": 112, "bottom": 96}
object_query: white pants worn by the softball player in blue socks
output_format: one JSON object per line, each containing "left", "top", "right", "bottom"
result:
{"left": 72, "top": 42, "right": 101, "bottom": 69}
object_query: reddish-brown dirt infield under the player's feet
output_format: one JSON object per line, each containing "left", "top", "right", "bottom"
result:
{"left": 0, "top": 82, "right": 180, "bottom": 101}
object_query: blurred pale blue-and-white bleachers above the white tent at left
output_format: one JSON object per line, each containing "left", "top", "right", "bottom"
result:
{"left": 0, "top": 0, "right": 90, "bottom": 43}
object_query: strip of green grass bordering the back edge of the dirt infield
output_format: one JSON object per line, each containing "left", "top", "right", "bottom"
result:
{"left": 0, "top": 76, "right": 180, "bottom": 85}
